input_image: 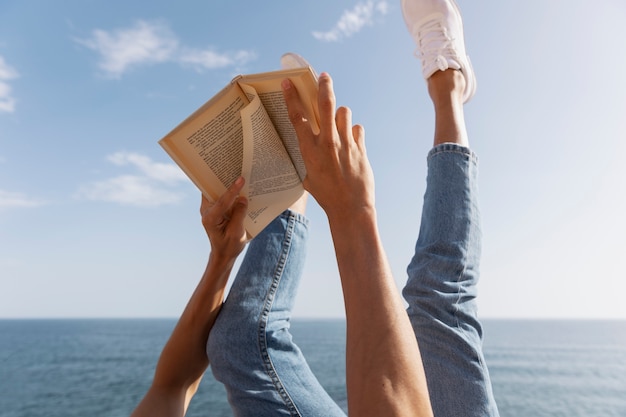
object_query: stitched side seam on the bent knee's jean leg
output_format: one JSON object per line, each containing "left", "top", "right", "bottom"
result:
{"left": 258, "top": 212, "right": 301, "bottom": 417}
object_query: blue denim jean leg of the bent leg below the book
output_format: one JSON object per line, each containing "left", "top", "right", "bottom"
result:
{"left": 207, "top": 211, "right": 345, "bottom": 417}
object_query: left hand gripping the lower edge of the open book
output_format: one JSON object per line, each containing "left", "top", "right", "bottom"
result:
{"left": 200, "top": 177, "right": 248, "bottom": 260}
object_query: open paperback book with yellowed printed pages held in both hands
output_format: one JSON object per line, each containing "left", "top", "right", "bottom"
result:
{"left": 159, "top": 68, "right": 319, "bottom": 237}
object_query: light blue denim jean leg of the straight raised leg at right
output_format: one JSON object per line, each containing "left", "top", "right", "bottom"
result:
{"left": 403, "top": 144, "right": 499, "bottom": 417}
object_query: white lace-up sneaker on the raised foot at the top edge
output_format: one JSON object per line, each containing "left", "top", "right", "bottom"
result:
{"left": 402, "top": 0, "right": 476, "bottom": 103}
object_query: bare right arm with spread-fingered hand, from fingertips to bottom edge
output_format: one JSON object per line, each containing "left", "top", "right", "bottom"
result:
{"left": 283, "top": 74, "right": 432, "bottom": 417}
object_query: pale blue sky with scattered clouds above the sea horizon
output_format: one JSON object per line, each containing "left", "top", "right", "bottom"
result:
{"left": 0, "top": 0, "right": 626, "bottom": 318}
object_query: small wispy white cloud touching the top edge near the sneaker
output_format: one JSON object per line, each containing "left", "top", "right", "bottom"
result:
{"left": 313, "top": 1, "right": 389, "bottom": 42}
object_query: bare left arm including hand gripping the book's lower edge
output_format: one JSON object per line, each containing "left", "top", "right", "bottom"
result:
{"left": 131, "top": 179, "right": 247, "bottom": 417}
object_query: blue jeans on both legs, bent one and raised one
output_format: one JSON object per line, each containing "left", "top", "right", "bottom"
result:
{"left": 207, "top": 144, "right": 498, "bottom": 417}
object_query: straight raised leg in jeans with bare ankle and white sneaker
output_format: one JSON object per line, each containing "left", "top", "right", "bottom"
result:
{"left": 403, "top": 0, "right": 498, "bottom": 417}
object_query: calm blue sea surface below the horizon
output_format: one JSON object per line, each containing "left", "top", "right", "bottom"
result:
{"left": 0, "top": 319, "right": 626, "bottom": 417}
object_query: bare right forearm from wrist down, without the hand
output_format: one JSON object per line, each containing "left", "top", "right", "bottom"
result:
{"left": 329, "top": 209, "right": 432, "bottom": 416}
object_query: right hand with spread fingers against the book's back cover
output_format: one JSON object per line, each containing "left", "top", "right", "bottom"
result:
{"left": 282, "top": 73, "right": 374, "bottom": 219}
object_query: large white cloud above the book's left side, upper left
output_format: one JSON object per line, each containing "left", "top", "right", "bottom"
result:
{"left": 76, "top": 20, "right": 255, "bottom": 79}
